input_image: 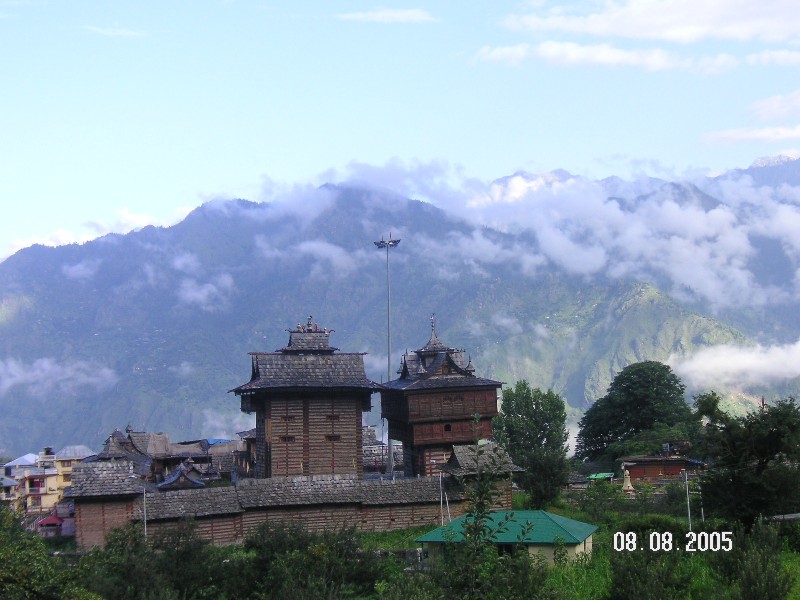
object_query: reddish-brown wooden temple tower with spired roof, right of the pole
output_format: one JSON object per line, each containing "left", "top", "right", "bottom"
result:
{"left": 381, "top": 319, "right": 503, "bottom": 476}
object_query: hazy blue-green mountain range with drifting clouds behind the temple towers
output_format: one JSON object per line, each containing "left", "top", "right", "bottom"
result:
{"left": 0, "top": 159, "right": 800, "bottom": 456}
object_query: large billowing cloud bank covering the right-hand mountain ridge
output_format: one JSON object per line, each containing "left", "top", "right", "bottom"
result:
{"left": 336, "top": 163, "right": 800, "bottom": 309}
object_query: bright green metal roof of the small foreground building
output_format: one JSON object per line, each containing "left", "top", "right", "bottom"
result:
{"left": 415, "top": 510, "right": 597, "bottom": 545}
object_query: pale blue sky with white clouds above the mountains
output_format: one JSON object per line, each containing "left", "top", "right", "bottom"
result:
{"left": 0, "top": 0, "right": 800, "bottom": 258}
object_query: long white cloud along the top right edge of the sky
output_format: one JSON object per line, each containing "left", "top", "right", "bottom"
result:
{"left": 505, "top": 0, "right": 800, "bottom": 44}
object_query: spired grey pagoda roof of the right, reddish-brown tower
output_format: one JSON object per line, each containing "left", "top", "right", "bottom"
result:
{"left": 384, "top": 318, "right": 503, "bottom": 391}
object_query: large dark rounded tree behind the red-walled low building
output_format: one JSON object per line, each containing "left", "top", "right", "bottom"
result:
{"left": 575, "top": 361, "right": 694, "bottom": 460}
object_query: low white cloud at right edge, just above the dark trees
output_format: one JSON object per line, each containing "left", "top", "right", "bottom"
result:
{"left": 667, "top": 340, "right": 800, "bottom": 390}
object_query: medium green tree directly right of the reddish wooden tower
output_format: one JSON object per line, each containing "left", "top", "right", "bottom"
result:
{"left": 493, "top": 380, "right": 568, "bottom": 508}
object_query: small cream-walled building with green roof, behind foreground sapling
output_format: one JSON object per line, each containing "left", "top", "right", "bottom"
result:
{"left": 415, "top": 510, "right": 597, "bottom": 564}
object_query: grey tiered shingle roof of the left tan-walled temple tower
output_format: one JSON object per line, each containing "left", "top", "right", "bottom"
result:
{"left": 230, "top": 317, "right": 381, "bottom": 395}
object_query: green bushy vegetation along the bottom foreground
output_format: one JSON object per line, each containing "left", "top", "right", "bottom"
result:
{"left": 0, "top": 500, "right": 800, "bottom": 600}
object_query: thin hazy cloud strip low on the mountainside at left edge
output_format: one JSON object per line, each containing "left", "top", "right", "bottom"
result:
{"left": 0, "top": 358, "right": 119, "bottom": 398}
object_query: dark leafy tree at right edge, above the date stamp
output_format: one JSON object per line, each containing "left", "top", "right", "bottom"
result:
{"left": 696, "top": 392, "right": 800, "bottom": 525}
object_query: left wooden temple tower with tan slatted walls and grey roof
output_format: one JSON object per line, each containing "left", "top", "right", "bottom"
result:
{"left": 231, "top": 317, "right": 381, "bottom": 478}
